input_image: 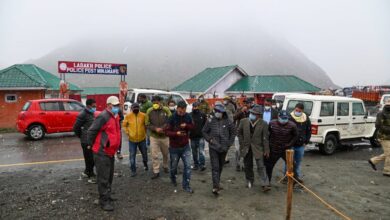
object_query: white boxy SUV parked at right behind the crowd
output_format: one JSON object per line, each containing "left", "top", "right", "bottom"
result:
{"left": 282, "top": 94, "right": 380, "bottom": 155}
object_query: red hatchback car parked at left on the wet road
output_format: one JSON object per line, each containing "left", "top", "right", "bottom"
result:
{"left": 16, "top": 99, "right": 85, "bottom": 140}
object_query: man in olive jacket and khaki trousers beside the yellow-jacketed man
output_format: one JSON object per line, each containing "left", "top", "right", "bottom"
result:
{"left": 146, "top": 96, "right": 172, "bottom": 179}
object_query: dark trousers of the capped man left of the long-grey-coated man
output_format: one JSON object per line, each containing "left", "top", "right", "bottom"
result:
{"left": 209, "top": 148, "right": 227, "bottom": 188}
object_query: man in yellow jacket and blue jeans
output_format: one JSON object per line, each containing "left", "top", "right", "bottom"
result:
{"left": 122, "top": 103, "right": 149, "bottom": 177}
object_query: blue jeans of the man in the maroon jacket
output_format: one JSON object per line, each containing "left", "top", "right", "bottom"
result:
{"left": 169, "top": 144, "right": 191, "bottom": 189}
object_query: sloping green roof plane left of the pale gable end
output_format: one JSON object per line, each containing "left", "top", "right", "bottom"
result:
{"left": 172, "top": 65, "right": 242, "bottom": 92}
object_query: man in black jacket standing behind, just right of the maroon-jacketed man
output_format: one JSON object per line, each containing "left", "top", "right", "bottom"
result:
{"left": 190, "top": 102, "right": 207, "bottom": 171}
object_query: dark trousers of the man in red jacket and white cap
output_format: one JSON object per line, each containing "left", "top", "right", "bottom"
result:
{"left": 93, "top": 154, "right": 115, "bottom": 203}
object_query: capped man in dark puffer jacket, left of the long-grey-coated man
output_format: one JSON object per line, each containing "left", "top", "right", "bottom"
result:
{"left": 202, "top": 104, "right": 236, "bottom": 195}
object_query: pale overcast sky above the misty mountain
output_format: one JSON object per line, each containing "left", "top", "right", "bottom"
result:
{"left": 0, "top": 0, "right": 390, "bottom": 86}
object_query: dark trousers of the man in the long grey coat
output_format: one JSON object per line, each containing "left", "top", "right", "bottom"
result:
{"left": 244, "top": 147, "right": 269, "bottom": 186}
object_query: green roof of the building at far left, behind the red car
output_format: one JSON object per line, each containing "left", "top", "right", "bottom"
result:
{"left": 0, "top": 64, "right": 81, "bottom": 91}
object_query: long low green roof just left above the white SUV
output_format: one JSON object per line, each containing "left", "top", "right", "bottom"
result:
{"left": 226, "top": 75, "right": 321, "bottom": 93}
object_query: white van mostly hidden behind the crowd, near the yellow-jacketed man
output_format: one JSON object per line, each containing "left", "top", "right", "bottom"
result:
{"left": 123, "top": 89, "right": 192, "bottom": 115}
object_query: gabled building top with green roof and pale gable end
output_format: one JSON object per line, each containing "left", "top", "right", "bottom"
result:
{"left": 172, "top": 65, "right": 248, "bottom": 98}
